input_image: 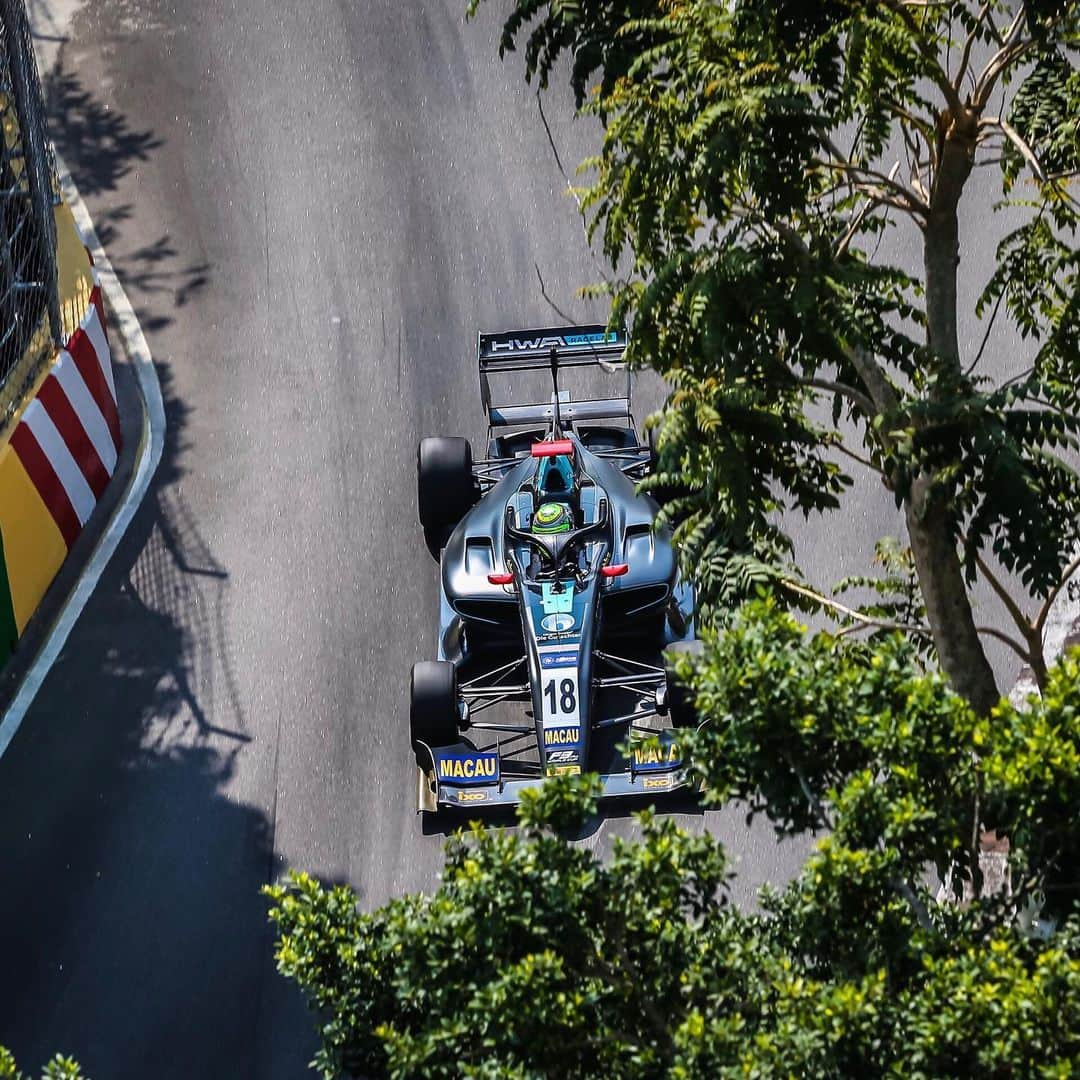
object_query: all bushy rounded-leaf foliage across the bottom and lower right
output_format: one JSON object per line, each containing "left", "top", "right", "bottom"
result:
{"left": 268, "top": 600, "right": 1080, "bottom": 1078}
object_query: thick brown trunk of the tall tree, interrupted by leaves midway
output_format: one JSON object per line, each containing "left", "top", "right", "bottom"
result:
{"left": 904, "top": 114, "right": 1000, "bottom": 714}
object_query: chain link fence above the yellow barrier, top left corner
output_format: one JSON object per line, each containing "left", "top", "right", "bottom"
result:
{"left": 0, "top": 0, "right": 63, "bottom": 431}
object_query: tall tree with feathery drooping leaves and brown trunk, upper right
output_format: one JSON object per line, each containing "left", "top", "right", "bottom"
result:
{"left": 472, "top": 0, "right": 1080, "bottom": 713}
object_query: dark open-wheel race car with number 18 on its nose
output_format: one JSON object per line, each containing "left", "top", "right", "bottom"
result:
{"left": 409, "top": 326, "right": 694, "bottom": 812}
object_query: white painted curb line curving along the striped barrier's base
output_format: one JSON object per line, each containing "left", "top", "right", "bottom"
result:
{"left": 0, "top": 153, "right": 165, "bottom": 757}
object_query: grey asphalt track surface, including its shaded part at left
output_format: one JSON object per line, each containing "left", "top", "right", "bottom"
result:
{"left": 0, "top": 0, "right": 1023, "bottom": 1080}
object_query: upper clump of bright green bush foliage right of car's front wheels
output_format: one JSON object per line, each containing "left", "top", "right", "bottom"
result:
{"left": 665, "top": 600, "right": 1080, "bottom": 920}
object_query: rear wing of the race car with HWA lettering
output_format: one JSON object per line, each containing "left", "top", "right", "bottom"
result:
{"left": 476, "top": 324, "right": 633, "bottom": 428}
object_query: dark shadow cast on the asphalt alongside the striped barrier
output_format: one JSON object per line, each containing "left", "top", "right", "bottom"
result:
{"left": 0, "top": 73, "right": 315, "bottom": 1080}
